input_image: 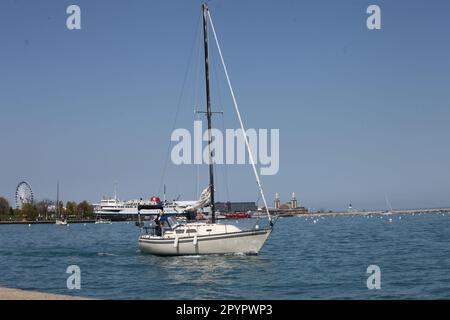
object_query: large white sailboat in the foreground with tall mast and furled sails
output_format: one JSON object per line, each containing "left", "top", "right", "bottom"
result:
{"left": 138, "top": 3, "right": 274, "bottom": 256}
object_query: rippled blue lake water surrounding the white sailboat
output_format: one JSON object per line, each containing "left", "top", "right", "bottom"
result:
{"left": 0, "top": 213, "right": 450, "bottom": 299}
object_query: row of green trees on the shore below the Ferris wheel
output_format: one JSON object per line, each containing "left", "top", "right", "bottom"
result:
{"left": 0, "top": 197, "right": 94, "bottom": 221}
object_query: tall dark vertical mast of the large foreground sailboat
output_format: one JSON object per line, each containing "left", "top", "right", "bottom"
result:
{"left": 202, "top": 3, "right": 216, "bottom": 223}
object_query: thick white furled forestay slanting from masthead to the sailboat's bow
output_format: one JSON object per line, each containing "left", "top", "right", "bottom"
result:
{"left": 207, "top": 11, "right": 273, "bottom": 226}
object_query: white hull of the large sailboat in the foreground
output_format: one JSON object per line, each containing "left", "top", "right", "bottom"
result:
{"left": 139, "top": 229, "right": 272, "bottom": 256}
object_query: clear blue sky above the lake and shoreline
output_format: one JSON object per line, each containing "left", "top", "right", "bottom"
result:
{"left": 0, "top": 0, "right": 450, "bottom": 210}
